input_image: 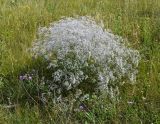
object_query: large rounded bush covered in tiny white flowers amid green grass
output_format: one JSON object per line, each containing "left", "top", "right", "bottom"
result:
{"left": 31, "top": 17, "right": 140, "bottom": 100}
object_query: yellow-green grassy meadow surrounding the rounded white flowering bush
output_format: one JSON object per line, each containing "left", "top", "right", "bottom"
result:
{"left": 0, "top": 0, "right": 160, "bottom": 124}
